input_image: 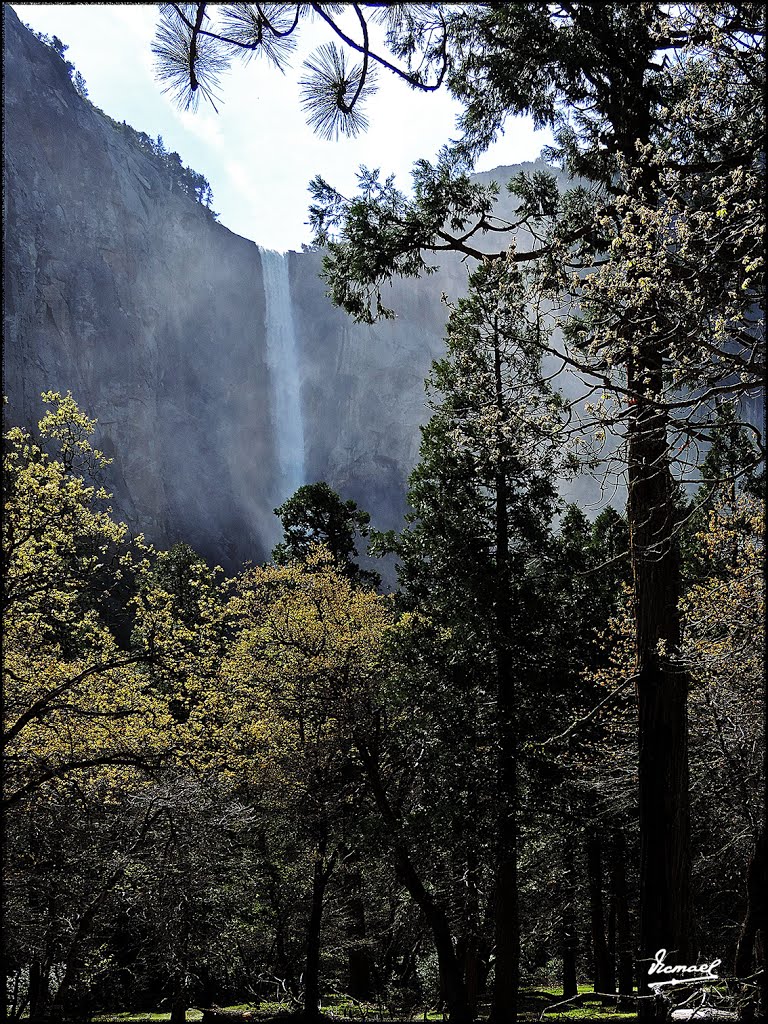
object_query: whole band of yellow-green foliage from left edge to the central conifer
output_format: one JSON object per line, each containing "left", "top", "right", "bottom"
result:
{"left": 3, "top": 392, "right": 391, "bottom": 804}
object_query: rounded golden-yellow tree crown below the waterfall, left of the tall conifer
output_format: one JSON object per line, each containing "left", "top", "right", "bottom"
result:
{"left": 188, "top": 546, "right": 391, "bottom": 790}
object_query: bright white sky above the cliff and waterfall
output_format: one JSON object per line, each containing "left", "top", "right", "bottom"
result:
{"left": 12, "top": 4, "right": 550, "bottom": 252}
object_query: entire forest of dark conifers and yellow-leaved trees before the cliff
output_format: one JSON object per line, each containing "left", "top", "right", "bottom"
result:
{"left": 3, "top": 2, "right": 768, "bottom": 1024}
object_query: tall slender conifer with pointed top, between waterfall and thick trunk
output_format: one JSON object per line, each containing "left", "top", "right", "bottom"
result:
{"left": 387, "top": 262, "right": 562, "bottom": 1020}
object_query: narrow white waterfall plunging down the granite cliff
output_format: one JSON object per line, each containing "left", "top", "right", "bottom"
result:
{"left": 259, "top": 248, "right": 306, "bottom": 502}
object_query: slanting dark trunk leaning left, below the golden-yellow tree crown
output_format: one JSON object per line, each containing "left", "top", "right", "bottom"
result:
{"left": 357, "top": 739, "right": 472, "bottom": 1024}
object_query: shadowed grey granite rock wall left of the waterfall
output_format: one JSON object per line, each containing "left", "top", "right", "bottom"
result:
{"left": 3, "top": 5, "right": 275, "bottom": 563}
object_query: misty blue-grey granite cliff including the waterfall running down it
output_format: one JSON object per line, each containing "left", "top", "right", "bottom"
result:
{"left": 4, "top": 5, "right": 557, "bottom": 568}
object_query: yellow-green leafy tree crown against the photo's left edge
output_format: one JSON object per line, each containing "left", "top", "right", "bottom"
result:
{"left": 3, "top": 392, "right": 174, "bottom": 803}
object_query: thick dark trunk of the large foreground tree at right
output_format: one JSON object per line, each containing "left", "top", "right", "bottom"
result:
{"left": 628, "top": 346, "right": 690, "bottom": 1020}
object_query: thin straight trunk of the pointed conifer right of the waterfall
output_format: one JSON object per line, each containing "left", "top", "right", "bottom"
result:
{"left": 489, "top": 329, "right": 520, "bottom": 1024}
